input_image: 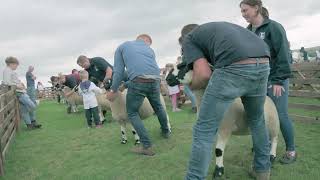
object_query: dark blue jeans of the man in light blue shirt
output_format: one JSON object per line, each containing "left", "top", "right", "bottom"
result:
{"left": 126, "top": 81, "right": 169, "bottom": 148}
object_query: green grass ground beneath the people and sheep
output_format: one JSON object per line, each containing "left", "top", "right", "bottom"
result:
{"left": 0, "top": 99, "right": 320, "bottom": 180}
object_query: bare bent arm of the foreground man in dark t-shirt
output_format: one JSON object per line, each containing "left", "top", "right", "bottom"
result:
{"left": 190, "top": 58, "right": 212, "bottom": 90}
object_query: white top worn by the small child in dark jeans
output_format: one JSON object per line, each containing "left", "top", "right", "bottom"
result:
{"left": 79, "top": 82, "right": 102, "bottom": 109}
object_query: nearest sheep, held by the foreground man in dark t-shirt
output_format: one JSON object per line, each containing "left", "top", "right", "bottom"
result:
{"left": 174, "top": 63, "right": 279, "bottom": 178}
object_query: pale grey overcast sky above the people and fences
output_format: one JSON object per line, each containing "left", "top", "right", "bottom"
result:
{"left": 0, "top": 0, "right": 320, "bottom": 86}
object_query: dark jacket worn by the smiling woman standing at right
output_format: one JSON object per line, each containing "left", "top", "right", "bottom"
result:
{"left": 248, "top": 19, "right": 292, "bottom": 85}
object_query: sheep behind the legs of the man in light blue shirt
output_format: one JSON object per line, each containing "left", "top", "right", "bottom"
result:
{"left": 110, "top": 90, "right": 171, "bottom": 145}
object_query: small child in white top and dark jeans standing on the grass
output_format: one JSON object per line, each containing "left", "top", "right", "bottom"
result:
{"left": 78, "top": 70, "right": 102, "bottom": 128}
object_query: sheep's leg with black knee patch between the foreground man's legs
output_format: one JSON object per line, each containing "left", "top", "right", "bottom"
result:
{"left": 213, "top": 129, "right": 231, "bottom": 178}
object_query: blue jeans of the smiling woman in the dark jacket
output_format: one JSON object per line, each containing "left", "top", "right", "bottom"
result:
{"left": 267, "top": 79, "right": 295, "bottom": 151}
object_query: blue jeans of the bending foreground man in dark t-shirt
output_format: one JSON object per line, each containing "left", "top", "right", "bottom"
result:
{"left": 186, "top": 63, "right": 270, "bottom": 180}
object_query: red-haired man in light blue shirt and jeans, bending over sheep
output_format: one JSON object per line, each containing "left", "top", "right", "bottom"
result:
{"left": 107, "top": 34, "right": 170, "bottom": 156}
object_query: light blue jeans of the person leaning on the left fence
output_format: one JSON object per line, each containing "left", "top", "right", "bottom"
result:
{"left": 18, "top": 93, "right": 36, "bottom": 125}
